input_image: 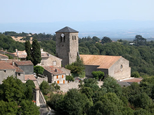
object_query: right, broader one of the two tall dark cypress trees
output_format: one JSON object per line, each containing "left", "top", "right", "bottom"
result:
{"left": 32, "top": 40, "right": 41, "bottom": 65}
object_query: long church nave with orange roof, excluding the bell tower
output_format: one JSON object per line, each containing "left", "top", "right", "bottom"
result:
{"left": 80, "top": 55, "right": 131, "bottom": 80}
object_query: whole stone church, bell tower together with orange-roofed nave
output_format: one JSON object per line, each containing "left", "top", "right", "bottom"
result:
{"left": 56, "top": 27, "right": 131, "bottom": 80}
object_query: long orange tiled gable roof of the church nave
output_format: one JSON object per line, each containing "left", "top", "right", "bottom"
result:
{"left": 80, "top": 55, "right": 122, "bottom": 69}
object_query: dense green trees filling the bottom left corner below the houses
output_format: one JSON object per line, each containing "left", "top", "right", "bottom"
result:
{"left": 0, "top": 76, "right": 40, "bottom": 115}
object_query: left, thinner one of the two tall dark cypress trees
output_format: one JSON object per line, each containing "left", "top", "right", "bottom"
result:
{"left": 25, "top": 40, "right": 33, "bottom": 62}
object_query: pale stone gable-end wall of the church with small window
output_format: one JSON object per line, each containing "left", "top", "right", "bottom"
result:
{"left": 109, "top": 57, "right": 131, "bottom": 80}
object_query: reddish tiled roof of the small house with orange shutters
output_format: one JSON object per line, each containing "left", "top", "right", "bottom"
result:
{"left": 43, "top": 66, "right": 65, "bottom": 75}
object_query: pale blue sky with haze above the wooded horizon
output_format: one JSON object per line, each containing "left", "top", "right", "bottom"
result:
{"left": 0, "top": 0, "right": 154, "bottom": 37}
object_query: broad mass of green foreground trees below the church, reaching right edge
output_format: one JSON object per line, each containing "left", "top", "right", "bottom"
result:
{"left": 48, "top": 77, "right": 154, "bottom": 115}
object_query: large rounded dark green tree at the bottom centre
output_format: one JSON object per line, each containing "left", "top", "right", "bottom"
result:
{"left": 56, "top": 89, "right": 91, "bottom": 115}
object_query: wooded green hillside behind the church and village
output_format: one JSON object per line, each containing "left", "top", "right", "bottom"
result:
{"left": 0, "top": 34, "right": 154, "bottom": 76}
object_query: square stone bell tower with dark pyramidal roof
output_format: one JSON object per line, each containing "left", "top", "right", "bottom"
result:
{"left": 56, "top": 27, "right": 78, "bottom": 67}
